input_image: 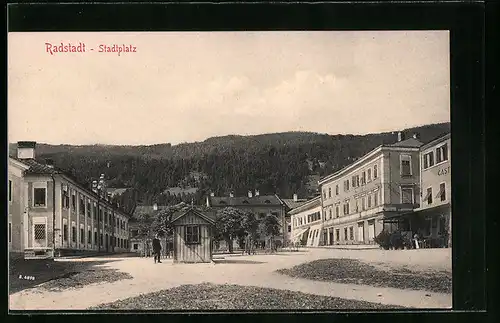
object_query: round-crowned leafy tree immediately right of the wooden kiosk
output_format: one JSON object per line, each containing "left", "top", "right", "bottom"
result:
{"left": 215, "top": 207, "right": 244, "bottom": 253}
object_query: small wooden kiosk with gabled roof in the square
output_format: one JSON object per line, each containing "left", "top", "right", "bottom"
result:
{"left": 172, "top": 207, "right": 215, "bottom": 263}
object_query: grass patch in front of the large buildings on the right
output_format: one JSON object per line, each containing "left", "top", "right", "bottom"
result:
{"left": 277, "top": 258, "right": 452, "bottom": 293}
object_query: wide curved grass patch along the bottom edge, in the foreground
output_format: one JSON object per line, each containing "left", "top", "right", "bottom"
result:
{"left": 90, "top": 283, "right": 401, "bottom": 310}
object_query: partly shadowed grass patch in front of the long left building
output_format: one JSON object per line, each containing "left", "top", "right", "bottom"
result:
{"left": 9, "top": 259, "right": 132, "bottom": 294}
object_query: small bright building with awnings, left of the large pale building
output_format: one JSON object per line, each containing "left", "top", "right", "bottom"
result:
{"left": 288, "top": 196, "right": 323, "bottom": 247}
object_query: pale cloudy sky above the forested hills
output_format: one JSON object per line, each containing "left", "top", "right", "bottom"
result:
{"left": 8, "top": 31, "right": 450, "bottom": 145}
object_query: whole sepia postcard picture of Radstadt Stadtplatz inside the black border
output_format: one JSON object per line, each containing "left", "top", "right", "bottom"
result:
{"left": 7, "top": 30, "right": 458, "bottom": 312}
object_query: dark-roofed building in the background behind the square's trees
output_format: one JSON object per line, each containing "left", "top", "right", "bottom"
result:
{"left": 206, "top": 190, "right": 288, "bottom": 243}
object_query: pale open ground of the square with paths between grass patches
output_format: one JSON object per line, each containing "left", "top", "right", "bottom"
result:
{"left": 10, "top": 249, "right": 452, "bottom": 310}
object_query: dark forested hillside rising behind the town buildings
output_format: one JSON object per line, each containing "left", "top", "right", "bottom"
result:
{"left": 10, "top": 123, "right": 450, "bottom": 214}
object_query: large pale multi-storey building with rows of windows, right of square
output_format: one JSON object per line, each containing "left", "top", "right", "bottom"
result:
{"left": 319, "top": 133, "right": 422, "bottom": 245}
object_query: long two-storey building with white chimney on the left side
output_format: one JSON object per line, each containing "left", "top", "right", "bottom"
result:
{"left": 9, "top": 142, "right": 130, "bottom": 258}
